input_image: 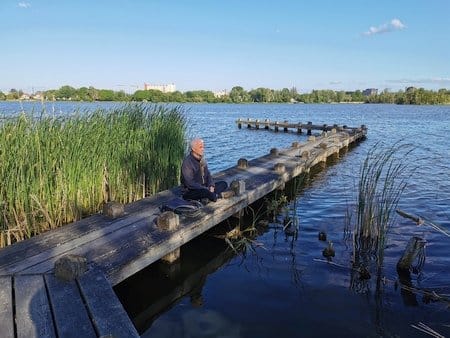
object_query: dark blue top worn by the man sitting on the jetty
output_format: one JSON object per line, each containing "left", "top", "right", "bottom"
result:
{"left": 181, "top": 153, "right": 214, "bottom": 189}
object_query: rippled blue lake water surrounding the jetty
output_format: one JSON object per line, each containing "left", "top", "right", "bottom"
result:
{"left": 0, "top": 103, "right": 450, "bottom": 337}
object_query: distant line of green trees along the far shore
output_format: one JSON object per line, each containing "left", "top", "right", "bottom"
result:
{"left": 0, "top": 86, "right": 450, "bottom": 104}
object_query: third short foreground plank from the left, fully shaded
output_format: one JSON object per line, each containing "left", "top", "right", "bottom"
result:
{"left": 44, "top": 274, "right": 97, "bottom": 338}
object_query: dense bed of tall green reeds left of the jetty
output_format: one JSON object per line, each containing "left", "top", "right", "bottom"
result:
{"left": 0, "top": 105, "right": 186, "bottom": 246}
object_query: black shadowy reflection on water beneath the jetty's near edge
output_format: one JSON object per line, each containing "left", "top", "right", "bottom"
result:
{"left": 115, "top": 235, "right": 235, "bottom": 333}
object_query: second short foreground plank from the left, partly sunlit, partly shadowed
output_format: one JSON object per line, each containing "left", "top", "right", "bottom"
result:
{"left": 14, "top": 275, "right": 56, "bottom": 338}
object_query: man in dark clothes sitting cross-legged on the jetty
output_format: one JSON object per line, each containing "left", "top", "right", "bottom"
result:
{"left": 181, "top": 138, "right": 228, "bottom": 202}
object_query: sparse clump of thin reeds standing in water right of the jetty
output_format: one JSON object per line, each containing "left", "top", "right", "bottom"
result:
{"left": 353, "top": 142, "right": 413, "bottom": 267}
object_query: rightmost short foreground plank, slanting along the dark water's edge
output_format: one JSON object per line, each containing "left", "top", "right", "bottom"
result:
{"left": 78, "top": 269, "right": 139, "bottom": 337}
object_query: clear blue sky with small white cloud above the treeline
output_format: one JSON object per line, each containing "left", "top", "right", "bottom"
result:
{"left": 0, "top": 0, "right": 450, "bottom": 92}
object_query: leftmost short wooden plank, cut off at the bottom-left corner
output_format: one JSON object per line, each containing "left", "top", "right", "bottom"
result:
{"left": 0, "top": 276, "right": 14, "bottom": 338}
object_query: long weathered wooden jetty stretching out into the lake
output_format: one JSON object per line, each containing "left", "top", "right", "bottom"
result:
{"left": 0, "top": 120, "right": 367, "bottom": 337}
